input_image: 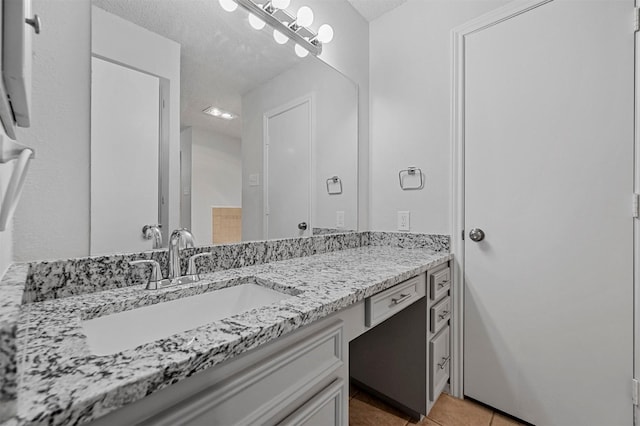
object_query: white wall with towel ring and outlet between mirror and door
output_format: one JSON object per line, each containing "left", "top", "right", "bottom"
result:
{"left": 370, "top": 0, "right": 506, "bottom": 234}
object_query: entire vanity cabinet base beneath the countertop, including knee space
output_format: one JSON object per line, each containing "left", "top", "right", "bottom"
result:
{"left": 92, "top": 264, "right": 452, "bottom": 426}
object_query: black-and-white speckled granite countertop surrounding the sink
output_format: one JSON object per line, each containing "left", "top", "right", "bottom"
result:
{"left": 4, "top": 246, "right": 451, "bottom": 425}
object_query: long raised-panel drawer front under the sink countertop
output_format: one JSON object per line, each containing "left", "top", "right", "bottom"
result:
{"left": 144, "top": 321, "right": 343, "bottom": 426}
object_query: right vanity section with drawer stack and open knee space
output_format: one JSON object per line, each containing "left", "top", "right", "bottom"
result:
{"left": 349, "top": 263, "right": 452, "bottom": 419}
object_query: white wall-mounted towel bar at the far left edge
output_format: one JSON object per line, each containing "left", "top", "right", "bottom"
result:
{"left": 0, "top": 136, "right": 35, "bottom": 232}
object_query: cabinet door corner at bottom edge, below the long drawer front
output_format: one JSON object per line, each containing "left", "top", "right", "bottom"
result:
{"left": 279, "top": 379, "right": 346, "bottom": 426}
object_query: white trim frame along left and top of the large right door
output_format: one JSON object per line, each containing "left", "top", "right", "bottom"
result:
{"left": 450, "top": 0, "right": 553, "bottom": 398}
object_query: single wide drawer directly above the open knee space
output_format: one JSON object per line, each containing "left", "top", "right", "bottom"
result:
{"left": 365, "top": 274, "right": 426, "bottom": 327}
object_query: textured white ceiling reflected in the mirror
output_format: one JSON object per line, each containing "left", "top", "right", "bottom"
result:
{"left": 93, "top": 0, "right": 308, "bottom": 137}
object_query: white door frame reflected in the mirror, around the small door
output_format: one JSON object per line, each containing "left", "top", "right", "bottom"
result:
{"left": 262, "top": 92, "right": 316, "bottom": 240}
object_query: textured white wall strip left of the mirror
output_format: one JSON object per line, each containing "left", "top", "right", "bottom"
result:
{"left": 12, "top": 0, "right": 91, "bottom": 261}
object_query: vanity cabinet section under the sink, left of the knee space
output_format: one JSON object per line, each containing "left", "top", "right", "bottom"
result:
{"left": 87, "top": 318, "right": 348, "bottom": 426}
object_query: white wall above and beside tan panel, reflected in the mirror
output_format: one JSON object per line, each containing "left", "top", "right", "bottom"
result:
{"left": 191, "top": 127, "right": 244, "bottom": 245}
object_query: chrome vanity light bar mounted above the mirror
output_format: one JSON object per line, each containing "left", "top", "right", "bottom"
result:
{"left": 235, "top": 0, "right": 322, "bottom": 56}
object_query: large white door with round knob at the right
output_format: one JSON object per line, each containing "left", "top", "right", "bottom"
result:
{"left": 464, "top": 0, "right": 634, "bottom": 426}
